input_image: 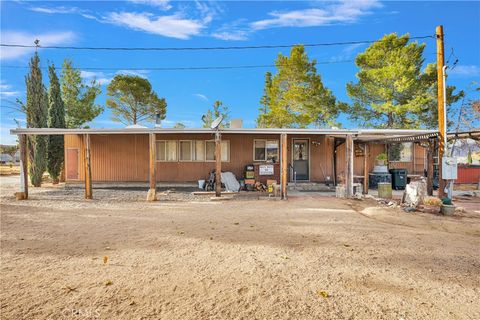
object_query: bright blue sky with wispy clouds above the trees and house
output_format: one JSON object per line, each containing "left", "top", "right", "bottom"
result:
{"left": 0, "top": 0, "right": 480, "bottom": 144}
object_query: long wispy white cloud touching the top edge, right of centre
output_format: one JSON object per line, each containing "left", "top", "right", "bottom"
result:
{"left": 251, "top": 0, "right": 381, "bottom": 30}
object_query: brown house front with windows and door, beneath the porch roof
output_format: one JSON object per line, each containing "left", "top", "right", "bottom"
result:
{"left": 65, "top": 129, "right": 426, "bottom": 183}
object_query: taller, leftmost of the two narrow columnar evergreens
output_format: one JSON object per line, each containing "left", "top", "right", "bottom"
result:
{"left": 25, "top": 52, "right": 48, "bottom": 187}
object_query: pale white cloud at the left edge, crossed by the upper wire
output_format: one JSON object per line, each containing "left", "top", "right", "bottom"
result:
{"left": 0, "top": 31, "right": 76, "bottom": 60}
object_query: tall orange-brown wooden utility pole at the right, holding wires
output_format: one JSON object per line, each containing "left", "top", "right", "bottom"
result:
{"left": 435, "top": 26, "right": 447, "bottom": 198}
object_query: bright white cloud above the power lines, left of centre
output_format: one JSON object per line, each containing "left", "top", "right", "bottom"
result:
{"left": 105, "top": 12, "right": 206, "bottom": 39}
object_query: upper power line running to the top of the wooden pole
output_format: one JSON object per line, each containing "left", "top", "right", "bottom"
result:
{"left": 0, "top": 35, "right": 435, "bottom": 51}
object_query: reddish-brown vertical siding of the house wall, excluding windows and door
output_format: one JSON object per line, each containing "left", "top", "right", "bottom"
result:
{"left": 65, "top": 134, "right": 425, "bottom": 182}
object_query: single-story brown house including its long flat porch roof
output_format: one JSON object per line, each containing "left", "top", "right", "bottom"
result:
{"left": 12, "top": 127, "right": 442, "bottom": 200}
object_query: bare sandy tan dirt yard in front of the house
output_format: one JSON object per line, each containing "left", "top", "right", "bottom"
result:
{"left": 0, "top": 178, "right": 480, "bottom": 319}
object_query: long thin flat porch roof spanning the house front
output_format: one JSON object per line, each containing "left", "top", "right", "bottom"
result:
{"left": 10, "top": 128, "right": 437, "bottom": 141}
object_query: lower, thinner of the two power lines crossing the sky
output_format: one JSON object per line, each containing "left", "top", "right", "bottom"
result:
{"left": 1, "top": 60, "right": 355, "bottom": 71}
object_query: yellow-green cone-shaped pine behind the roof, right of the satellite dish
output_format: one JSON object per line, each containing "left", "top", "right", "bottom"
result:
{"left": 257, "top": 45, "right": 345, "bottom": 128}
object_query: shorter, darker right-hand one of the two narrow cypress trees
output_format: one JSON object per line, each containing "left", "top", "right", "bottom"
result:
{"left": 47, "top": 65, "right": 65, "bottom": 184}
